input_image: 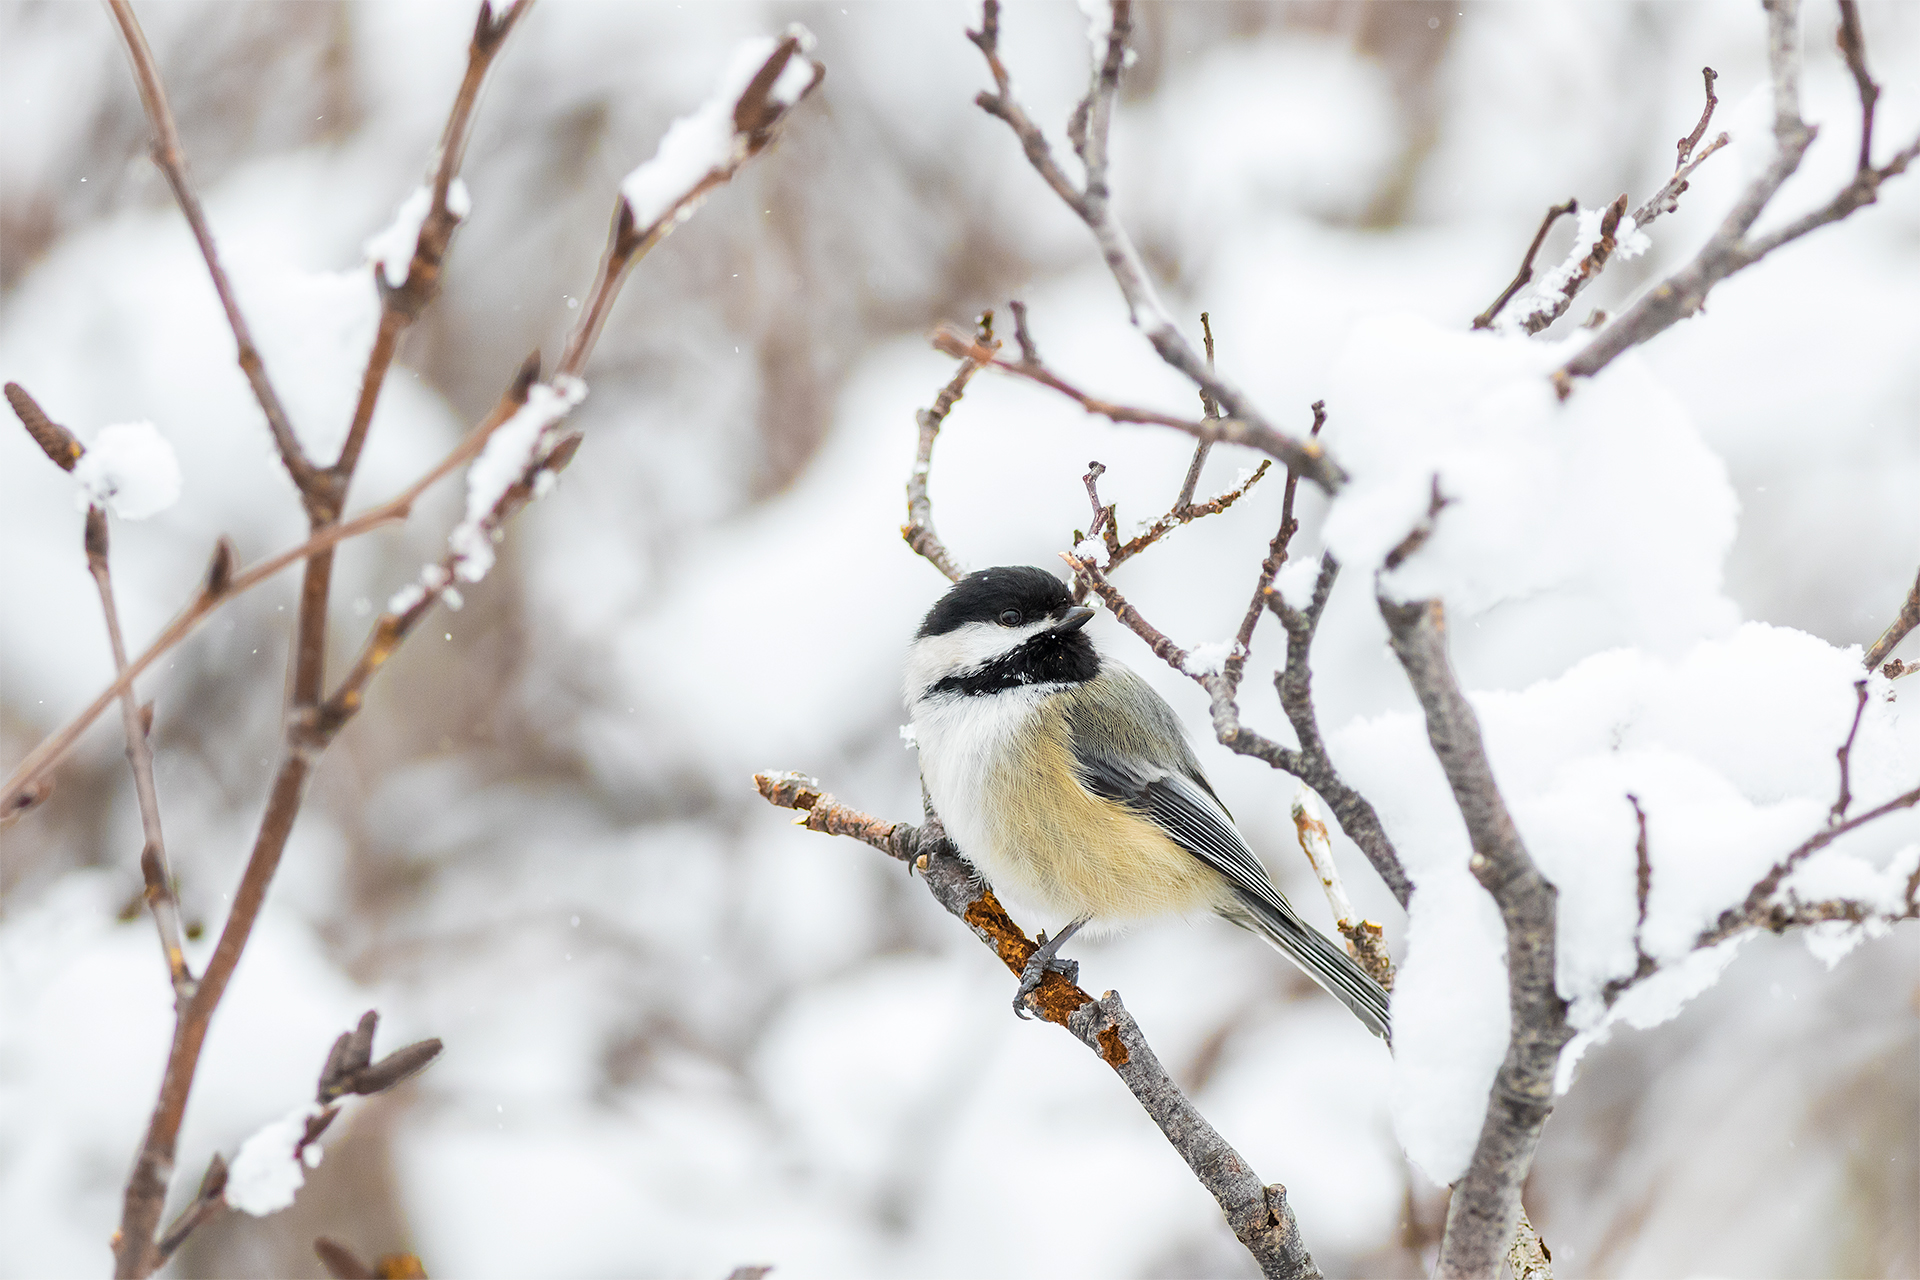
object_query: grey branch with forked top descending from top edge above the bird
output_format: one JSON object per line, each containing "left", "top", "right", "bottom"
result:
{"left": 968, "top": 0, "right": 1346, "bottom": 493}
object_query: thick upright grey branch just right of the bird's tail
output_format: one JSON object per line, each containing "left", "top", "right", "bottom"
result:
{"left": 1380, "top": 595, "right": 1572, "bottom": 1280}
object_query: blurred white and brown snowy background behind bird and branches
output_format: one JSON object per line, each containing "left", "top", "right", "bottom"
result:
{"left": 0, "top": 2, "right": 1920, "bottom": 1276}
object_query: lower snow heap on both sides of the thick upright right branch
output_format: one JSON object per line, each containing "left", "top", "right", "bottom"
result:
{"left": 1334, "top": 624, "right": 1920, "bottom": 1182}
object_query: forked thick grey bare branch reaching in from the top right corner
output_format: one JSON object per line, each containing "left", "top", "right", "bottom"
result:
{"left": 1553, "top": 0, "right": 1920, "bottom": 397}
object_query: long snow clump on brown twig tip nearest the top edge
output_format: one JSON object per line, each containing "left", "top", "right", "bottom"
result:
{"left": 620, "top": 23, "right": 814, "bottom": 226}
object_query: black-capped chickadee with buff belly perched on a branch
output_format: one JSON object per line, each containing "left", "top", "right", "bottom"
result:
{"left": 906, "top": 566, "right": 1392, "bottom": 1040}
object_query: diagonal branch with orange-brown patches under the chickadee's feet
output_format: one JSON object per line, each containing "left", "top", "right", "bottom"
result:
{"left": 753, "top": 773, "right": 1321, "bottom": 1280}
